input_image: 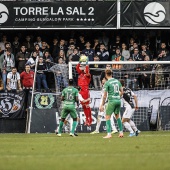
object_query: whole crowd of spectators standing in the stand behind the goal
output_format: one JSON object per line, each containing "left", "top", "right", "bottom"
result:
{"left": 0, "top": 31, "right": 170, "bottom": 92}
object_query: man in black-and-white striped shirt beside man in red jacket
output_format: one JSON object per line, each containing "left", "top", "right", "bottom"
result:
{"left": 6, "top": 67, "right": 22, "bottom": 92}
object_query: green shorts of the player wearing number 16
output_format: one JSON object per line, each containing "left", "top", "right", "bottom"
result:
{"left": 61, "top": 105, "right": 77, "bottom": 118}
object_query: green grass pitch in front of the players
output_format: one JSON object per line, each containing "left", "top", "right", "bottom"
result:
{"left": 0, "top": 132, "right": 170, "bottom": 170}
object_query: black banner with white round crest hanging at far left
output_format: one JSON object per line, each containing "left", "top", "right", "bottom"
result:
{"left": 0, "top": 92, "right": 25, "bottom": 119}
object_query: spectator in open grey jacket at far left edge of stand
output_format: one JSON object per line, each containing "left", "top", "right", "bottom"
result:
{"left": 0, "top": 48, "right": 15, "bottom": 89}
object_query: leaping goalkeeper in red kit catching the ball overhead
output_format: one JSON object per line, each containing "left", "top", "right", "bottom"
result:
{"left": 76, "top": 55, "right": 92, "bottom": 126}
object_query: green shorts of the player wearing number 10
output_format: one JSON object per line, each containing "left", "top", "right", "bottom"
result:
{"left": 106, "top": 100, "right": 121, "bottom": 115}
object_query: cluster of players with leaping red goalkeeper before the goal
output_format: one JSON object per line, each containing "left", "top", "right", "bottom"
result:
{"left": 57, "top": 56, "right": 140, "bottom": 138}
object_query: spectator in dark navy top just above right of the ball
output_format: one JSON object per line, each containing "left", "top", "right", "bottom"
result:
{"left": 82, "top": 41, "right": 95, "bottom": 61}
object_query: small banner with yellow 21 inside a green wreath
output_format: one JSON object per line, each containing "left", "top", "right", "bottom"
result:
{"left": 34, "top": 93, "right": 57, "bottom": 109}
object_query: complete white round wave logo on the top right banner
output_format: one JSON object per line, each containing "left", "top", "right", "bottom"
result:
{"left": 144, "top": 2, "right": 166, "bottom": 25}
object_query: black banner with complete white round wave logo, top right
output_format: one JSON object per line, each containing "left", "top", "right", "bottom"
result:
{"left": 120, "top": 1, "right": 170, "bottom": 27}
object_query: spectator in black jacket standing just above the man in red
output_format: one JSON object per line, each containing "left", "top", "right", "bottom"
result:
{"left": 16, "top": 45, "right": 30, "bottom": 73}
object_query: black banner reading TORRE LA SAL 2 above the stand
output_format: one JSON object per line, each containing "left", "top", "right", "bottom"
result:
{"left": 0, "top": 0, "right": 117, "bottom": 28}
